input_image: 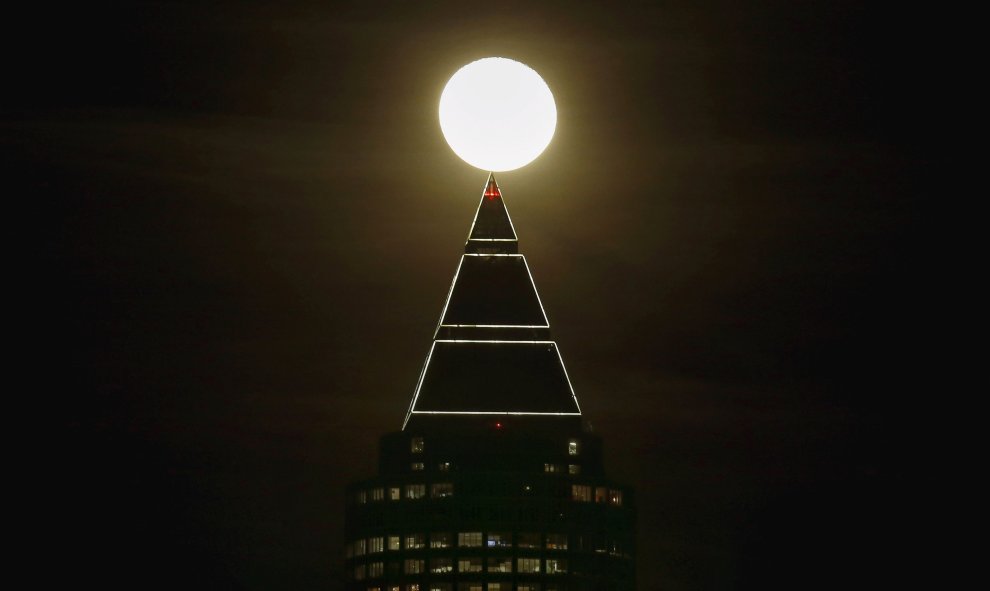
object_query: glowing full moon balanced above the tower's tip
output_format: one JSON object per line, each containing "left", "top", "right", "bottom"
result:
{"left": 440, "top": 57, "right": 557, "bottom": 172}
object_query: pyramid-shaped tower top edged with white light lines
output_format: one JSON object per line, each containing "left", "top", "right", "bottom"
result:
{"left": 403, "top": 175, "right": 581, "bottom": 429}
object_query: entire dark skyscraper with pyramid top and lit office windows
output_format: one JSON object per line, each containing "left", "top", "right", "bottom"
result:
{"left": 346, "top": 176, "right": 635, "bottom": 591}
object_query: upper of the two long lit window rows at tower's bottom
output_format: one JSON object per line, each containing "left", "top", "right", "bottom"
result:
{"left": 346, "top": 532, "right": 567, "bottom": 558}
